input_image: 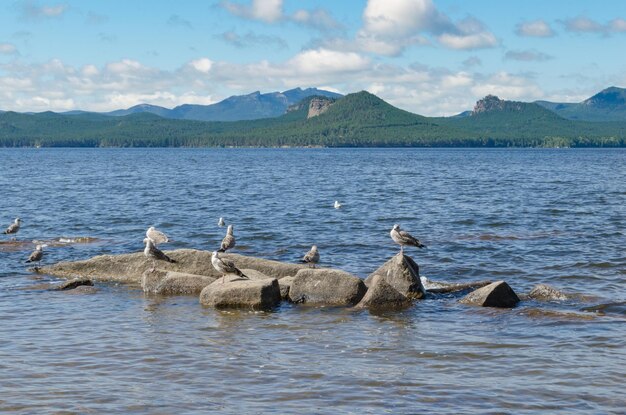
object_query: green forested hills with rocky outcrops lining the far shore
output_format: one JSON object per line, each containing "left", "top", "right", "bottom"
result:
{"left": 0, "top": 91, "right": 626, "bottom": 147}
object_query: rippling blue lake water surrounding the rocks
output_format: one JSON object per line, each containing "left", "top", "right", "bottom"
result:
{"left": 0, "top": 149, "right": 626, "bottom": 414}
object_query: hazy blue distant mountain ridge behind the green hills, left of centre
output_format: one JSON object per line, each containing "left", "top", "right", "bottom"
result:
{"left": 107, "top": 88, "right": 342, "bottom": 121}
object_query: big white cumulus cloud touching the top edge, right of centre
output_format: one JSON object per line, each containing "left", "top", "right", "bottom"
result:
{"left": 357, "top": 0, "right": 498, "bottom": 56}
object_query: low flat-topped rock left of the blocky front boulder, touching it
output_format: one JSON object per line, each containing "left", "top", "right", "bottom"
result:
{"left": 141, "top": 269, "right": 216, "bottom": 295}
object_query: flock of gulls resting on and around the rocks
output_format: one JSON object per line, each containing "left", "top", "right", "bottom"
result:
{"left": 3, "top": 211, "right": 426, "bottom": 283}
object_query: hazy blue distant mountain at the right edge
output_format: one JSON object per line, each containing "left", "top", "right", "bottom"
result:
{"left": 536, "top": 86, "right": 626, "bottom": 122}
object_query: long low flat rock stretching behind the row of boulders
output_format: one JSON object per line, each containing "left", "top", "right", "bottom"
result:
{"left": 40, "top": 249, "right": 306, "bottom": 285}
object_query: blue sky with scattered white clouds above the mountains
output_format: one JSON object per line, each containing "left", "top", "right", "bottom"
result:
{"left": 0, "top": 0, "right": 626, "bottom": 116}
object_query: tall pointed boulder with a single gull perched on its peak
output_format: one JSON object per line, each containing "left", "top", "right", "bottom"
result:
{"left": 365, "top": 253, "right": 425, "bottom": 299}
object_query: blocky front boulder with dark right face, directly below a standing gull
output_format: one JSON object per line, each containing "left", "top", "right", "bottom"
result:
{"left": 200, "top": 275, "right": 281, "bottom": 310}
